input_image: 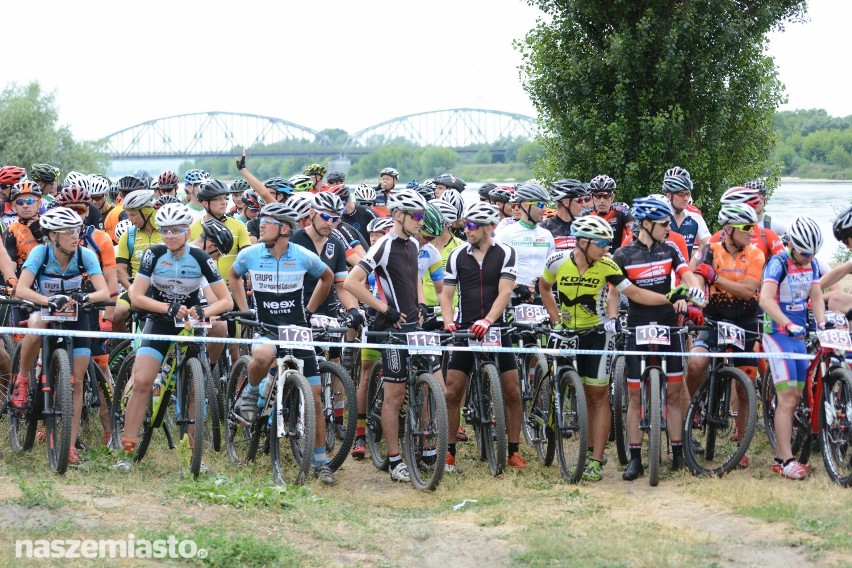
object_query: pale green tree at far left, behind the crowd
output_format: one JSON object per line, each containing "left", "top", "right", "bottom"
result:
{"left": 0, "top": 82, "right": 108, "bottom": 173}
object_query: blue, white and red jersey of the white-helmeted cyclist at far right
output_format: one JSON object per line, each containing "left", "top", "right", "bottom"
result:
{"left": 763, "top": 250, "right": 819, "bottom": 334}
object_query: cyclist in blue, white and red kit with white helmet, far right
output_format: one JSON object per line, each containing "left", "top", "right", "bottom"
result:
{"left": 760, "top": 217, "right": 825, "bottom": 479}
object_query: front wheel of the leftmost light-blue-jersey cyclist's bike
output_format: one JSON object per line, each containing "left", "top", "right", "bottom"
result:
{"left": 45, "top": 348, "right": 72, "bottom": 474}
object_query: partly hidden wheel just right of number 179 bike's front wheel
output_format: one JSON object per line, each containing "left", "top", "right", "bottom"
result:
{"left": 319, "top": 361, "right": 358, "bottom": 471}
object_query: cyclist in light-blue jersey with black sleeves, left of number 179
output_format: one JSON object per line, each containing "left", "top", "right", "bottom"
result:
{"left": 115, "top": 203, "right": 234, "bottom": 471}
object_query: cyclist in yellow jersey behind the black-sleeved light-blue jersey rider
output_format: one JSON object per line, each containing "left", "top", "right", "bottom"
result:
{"left": 112, "top": 189, "right": 163, "bottom": 332}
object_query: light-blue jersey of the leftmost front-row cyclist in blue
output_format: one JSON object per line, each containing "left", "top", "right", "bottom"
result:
{"left": 22, "top": 245, "right": 103, "bottom": 296}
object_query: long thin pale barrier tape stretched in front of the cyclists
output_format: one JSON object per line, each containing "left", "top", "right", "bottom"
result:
{"left": 0, "top": 327, "right": 824, "bottom": 361}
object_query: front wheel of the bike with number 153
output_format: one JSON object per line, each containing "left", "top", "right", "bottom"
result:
{"left": 554, "top": 368, "right": 589, "bottom": 483}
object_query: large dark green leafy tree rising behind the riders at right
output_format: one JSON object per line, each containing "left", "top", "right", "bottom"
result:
{"left": 516, "top": 0, "right": 806, "bottom": 222}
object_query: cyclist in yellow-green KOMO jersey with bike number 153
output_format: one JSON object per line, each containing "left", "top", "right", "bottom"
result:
{"left": 541, "top": 215, "right": 680, "bottom": 481}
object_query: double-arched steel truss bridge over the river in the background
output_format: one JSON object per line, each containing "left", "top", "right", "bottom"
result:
{"left": 105, "top": 108, "right": 537, "bottom": 160}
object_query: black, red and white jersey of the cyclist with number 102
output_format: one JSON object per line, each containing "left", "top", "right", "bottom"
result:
{"left": 612, "top": 240, "right": 689, "bottom": 326}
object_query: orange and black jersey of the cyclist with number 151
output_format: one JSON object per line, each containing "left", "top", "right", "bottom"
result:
{"left": 699, "top": 243, "right": 765, "bottom": 322}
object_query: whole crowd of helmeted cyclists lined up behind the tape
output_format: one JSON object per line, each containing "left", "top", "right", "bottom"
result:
{"left": 0, "top": 153, "right": 852, "bottom": 485}
